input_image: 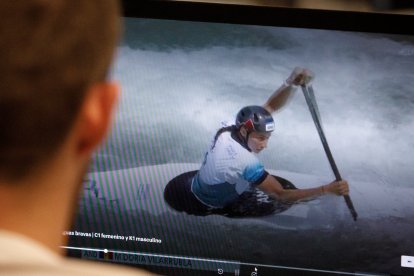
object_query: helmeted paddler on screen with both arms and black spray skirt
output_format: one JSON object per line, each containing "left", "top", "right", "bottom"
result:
{"left": 164, "top": 67, "right": 349, "bottom": 217}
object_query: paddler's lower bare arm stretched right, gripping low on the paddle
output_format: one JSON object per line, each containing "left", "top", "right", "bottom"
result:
{"left": 257, "top": 174, "right": 349, "bottom": 202}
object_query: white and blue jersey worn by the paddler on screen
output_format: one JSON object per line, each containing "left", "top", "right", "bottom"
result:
{"left": 191, "top": 126, "right": 267, "bottom": 208}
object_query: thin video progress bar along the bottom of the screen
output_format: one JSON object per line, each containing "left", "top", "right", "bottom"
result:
{"left": 61, "top": 246, "right": 382, "bottom": 276}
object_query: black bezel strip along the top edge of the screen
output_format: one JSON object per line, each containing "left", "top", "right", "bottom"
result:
{"left": 122, "top": 0, "right": 414, "bottom": 34}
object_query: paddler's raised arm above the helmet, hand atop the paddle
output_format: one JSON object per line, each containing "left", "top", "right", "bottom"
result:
{"left": 263, "top": 67, "right": 314, "bottom": 113}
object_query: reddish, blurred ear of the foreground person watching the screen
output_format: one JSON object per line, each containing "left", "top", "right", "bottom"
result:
{"left": 77, "top": 82, "right": 120, "bottom": 155}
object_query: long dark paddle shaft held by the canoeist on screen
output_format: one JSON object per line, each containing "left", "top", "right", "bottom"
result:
{"left": 302, "top": 86, "right": 358, "bottom": 220}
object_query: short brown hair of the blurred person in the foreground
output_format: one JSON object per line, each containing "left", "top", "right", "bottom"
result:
{"left": 0, "top": 0, "right": 120, "bottom": 181}
